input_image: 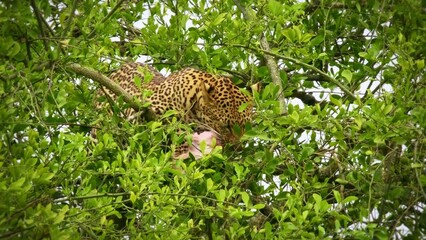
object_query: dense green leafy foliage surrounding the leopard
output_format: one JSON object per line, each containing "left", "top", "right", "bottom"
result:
{"left": 0, "top": 0, "right": 426, "bottom": 239}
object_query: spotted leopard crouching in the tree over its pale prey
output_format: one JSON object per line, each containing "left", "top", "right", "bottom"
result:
{"left": 96, "top": 62, "right": 253, "bottom": 158}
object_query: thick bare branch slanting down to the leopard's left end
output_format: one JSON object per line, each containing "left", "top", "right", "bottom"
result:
{"left": 67, "top": 63, "right": 145, "bottom": 111}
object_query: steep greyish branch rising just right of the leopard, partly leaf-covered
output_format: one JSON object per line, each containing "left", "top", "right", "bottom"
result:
{"left": 234, "top": 0, "right": 287, "bottom": 114}
